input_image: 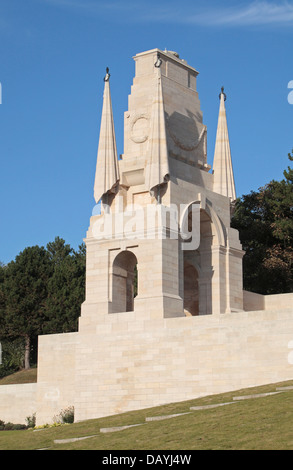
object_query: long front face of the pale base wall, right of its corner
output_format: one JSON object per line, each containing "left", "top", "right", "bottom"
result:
{"left": 75, "top": 309, "right": 293, "bottom": 420}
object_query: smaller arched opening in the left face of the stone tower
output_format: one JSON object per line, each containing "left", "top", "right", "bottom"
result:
{"left": 111, "top": 251, "right": 137, "bottom": 313}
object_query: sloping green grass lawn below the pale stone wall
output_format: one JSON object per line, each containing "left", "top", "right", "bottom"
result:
{"left": 0, "top": 380, "right": 293, "bottom": 451}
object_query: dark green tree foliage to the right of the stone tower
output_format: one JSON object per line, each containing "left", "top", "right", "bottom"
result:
{"left": 232, "top": 151, "right": 293, "bottom": 294}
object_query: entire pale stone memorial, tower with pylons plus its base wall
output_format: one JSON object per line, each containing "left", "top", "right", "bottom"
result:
{"left": 0, "top": 49, "right": 293, "bottom": 424}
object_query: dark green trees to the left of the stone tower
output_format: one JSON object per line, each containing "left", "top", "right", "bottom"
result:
{"left": 0, "top": 237, "right": 85, "bottom": 368}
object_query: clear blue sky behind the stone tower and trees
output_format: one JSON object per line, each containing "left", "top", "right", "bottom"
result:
{"left": 0, "top": 0, "right": 293, "bottom": 263}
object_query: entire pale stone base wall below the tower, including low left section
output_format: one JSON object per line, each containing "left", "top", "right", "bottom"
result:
{"left": 0, "top": 304, "right": 293, "bottom": 425}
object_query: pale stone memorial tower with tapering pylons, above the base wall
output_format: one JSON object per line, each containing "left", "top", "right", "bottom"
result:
{"left": 80, "top": 49, "right": 243, "bottom": 328}
